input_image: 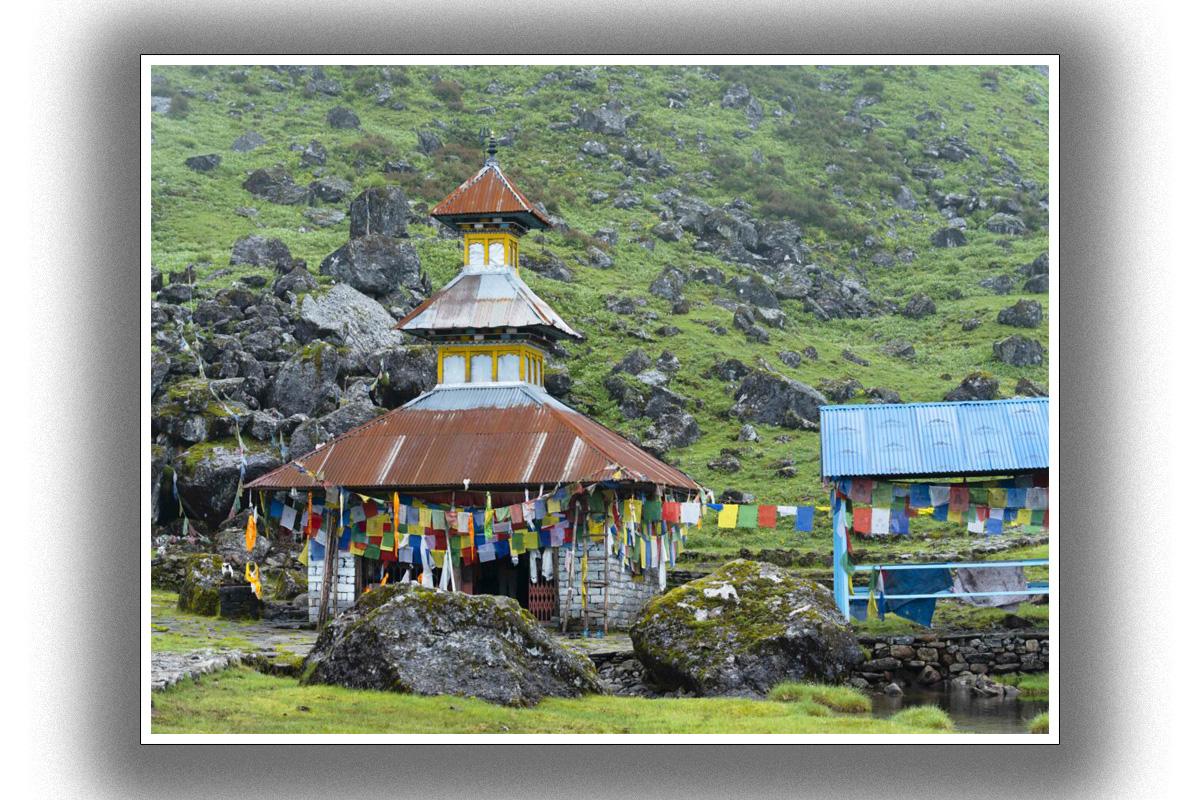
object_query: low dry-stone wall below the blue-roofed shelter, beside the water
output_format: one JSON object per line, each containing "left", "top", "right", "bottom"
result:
{"left": 851, "top": 631, "right": 1050, "bottom": 688}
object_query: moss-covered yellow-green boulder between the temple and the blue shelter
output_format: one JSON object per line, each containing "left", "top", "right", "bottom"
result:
{"left": 630, "top": 559, "right": 863, "bottom": 697}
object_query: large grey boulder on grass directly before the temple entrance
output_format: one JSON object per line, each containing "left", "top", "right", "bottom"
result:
{"left": 300, "top": 584, "right": 601, "bottom": 706}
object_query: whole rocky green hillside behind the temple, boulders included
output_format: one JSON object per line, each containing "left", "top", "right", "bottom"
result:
{"left": 150, "top": 67, "right": 1050, "bottom": 525}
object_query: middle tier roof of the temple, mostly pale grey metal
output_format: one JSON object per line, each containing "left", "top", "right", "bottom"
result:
{"left": 396, "top": 266, "right": 582, "bottom": 338}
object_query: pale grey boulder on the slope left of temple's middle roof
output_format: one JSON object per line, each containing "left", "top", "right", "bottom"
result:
{"left": 300, "top": 283, "right": 404, "bottom": 362}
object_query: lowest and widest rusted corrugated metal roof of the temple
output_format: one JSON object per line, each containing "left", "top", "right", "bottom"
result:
{"left": 248, "top": 385, "right": 698, "bottom": 491}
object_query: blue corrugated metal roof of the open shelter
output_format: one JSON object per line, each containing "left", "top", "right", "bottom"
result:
{"left": 821, "top": 397, "right": 1050, "bottom": 477}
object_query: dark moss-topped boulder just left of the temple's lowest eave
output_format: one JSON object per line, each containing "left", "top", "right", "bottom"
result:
{"left": 174, "top": 441, "right": 282, "bottom": 525}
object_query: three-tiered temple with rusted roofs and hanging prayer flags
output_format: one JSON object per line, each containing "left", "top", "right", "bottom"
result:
{"left": 247, "top": 143, "right": 701, "bottom": 630}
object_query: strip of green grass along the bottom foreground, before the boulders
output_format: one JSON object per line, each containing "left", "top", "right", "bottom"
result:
{"left": 151, "top": 668, "right": 950, "bottom": 733}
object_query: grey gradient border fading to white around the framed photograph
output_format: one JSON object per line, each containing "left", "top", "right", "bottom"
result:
{"left": 23, "top": 0, "right": 1185, "bottom": 800}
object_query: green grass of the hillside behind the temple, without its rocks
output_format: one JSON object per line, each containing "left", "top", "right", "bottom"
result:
{"left": 151, "top": 66, "right": 1049, "bottom": 513}
